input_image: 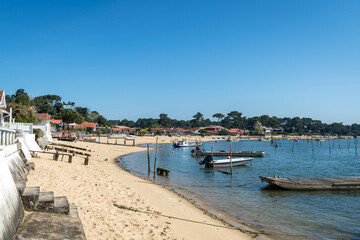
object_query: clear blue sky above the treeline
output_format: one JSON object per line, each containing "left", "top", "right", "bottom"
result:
{"left": 0, "top": 0, "right": 360, "bottom": 124}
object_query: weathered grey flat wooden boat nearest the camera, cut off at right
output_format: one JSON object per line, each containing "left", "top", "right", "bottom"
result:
{"left": 259, "top": 176, "right": 360, "bottom": 190}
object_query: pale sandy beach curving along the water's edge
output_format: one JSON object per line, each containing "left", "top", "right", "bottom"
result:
{"left": 27, "top": 137, "right": 252, "bottom": 240}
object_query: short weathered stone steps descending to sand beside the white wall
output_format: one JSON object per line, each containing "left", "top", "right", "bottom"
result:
{"left": 21, "top": 187, "right": 70, "bottom": 214}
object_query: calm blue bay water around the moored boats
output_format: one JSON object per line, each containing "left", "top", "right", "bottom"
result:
{"left": 120, "top": 140, "right": 360, "bottom": 239}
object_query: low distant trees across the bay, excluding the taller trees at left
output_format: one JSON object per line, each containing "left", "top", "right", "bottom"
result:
{"left": 108, "top": 111, "right": 360, "bottom": 136}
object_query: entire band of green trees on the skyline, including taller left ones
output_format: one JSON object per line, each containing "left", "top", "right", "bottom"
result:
{"left": 6, "top": 89, "right": 360, "bottom": 136}
